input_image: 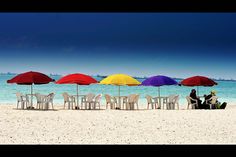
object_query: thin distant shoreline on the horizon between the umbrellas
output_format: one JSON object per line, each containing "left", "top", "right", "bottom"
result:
{"left": 0, "top": 72, "right": 236, "bottom": 82}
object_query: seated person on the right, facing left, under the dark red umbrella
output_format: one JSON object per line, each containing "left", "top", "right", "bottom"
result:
{"left": 203, "top": 91, "right": 227, "bottom": 109}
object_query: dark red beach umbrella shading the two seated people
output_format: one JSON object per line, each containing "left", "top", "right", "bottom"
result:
{"left": 180, "top": 76, "right": 217, "bottom": 94}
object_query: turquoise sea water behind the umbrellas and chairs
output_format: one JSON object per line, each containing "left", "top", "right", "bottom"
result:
{"left": 0, "top": 75, "right": 236, "bottom": 105}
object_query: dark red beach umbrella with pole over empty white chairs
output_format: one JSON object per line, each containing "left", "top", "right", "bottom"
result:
{"left": 7, "top": 71, "right": 55, "bottom": 108}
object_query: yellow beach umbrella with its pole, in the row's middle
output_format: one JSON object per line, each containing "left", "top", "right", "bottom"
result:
{"left": 100, "top": 74, "right": 140, "bottom": 106}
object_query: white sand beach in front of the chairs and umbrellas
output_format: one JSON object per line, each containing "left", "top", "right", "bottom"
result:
{"left": 0, "top": 104, "right": 236, "bottom": 144}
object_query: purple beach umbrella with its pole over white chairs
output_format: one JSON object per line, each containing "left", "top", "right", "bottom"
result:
{"left": 140, "top": 75, "right": 178, "bottom": 107}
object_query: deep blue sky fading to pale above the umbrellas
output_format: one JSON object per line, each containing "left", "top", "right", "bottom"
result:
{"left": 0, "top": 13, "right": 236, "bottom": 79}
